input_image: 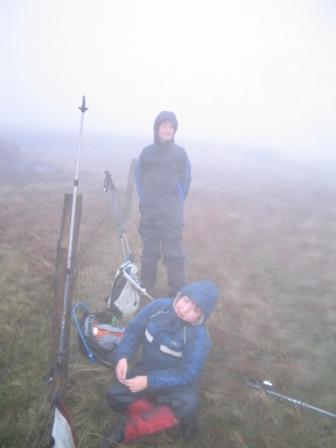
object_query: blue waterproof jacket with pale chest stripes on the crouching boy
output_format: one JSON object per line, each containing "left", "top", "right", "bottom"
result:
{"left": 116, "top": 280, "right": 218, "bottom": 390}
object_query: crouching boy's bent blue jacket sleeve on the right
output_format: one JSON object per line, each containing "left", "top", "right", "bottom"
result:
{"left": 147, "top": 327, "right": 211, "bottom": 390}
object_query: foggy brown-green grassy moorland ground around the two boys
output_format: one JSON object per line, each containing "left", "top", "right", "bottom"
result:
{"left": 0, "top": 151, "right": 336, "bottom": 448}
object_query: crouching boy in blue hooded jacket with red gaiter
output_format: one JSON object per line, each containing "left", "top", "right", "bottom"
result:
{"left": 101, "top": 280, "right": 218, "bottom": 448}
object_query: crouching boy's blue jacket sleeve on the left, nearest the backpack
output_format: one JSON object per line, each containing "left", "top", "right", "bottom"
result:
{"left": 114, "top": 300, "right": 168, "bottom": 362}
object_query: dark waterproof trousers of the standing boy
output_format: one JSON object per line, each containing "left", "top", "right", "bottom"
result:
{"left": 139, "top": 224, "right": 185, "bottom": 296}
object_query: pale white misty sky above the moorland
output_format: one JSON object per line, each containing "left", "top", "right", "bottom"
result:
{"left": 0, "top": 0, "right": 336, "bottom": 151}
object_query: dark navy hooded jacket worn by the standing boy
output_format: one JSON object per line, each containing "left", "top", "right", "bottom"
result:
{"left": 135, "top": 111, "right": 191, "bottom": 225}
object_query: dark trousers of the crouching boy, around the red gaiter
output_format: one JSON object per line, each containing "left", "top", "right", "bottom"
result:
{"left": 106, "top": 367, "right": 199, "bottom": 425}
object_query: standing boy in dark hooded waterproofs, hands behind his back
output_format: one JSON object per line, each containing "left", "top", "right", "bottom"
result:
{"left": 135, "top": 111, "right": 191, "bottom": 297}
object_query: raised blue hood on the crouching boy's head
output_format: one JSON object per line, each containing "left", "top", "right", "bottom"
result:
{"left": 180, "top": 280, "right": 219, "bottom": 320}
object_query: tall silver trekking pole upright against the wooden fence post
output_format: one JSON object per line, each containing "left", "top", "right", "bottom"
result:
{"left": 57, "top": 96, "right": 88, "bottom": 367}
